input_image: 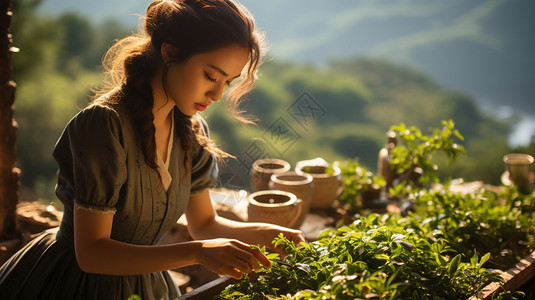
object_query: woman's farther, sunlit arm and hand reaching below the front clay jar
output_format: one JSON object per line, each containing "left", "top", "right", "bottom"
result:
{"left": 186, "top": 189, "right": 305, "bottom": 253}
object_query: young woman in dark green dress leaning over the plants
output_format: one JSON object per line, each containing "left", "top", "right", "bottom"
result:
{"left": 0, "top": 0, "right": 303, "bottom": 300}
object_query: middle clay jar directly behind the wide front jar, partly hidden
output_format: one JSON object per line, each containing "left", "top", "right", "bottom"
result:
{"left": 269, "top": 172, "right": 314, "bottom": 227}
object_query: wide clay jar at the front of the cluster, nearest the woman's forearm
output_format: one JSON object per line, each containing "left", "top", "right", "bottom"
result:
{"left": 247, "top": 190, "right": 303, "bottom": 228}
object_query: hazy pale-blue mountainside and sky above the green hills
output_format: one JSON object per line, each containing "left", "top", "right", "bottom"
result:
{"left": 34, "top": 0, "right": 535, "bottom": 142}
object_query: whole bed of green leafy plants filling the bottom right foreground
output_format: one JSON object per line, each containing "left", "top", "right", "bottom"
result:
{"left": 219, "top": 189, "right": 535, "bottom": 299}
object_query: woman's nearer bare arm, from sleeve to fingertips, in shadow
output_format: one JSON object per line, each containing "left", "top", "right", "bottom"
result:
{"left": 74, "top": 205, "right": 269, "bottom": 278}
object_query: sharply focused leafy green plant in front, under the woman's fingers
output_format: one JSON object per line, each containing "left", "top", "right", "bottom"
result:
{"left": 219, "top": 226, "right": 499, "bottom": 299}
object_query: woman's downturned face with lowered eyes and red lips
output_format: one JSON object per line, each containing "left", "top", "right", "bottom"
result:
{"left": 164, "top": 45, "right": 249, "bottom": 116}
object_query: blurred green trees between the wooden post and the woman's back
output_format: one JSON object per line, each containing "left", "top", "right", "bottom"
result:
{"left": 12, "top": 0, "right": 131, "bottom": 201}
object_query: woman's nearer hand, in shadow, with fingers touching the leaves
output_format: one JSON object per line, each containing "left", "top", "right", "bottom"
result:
{"left": 198, "top": 239, "right": 271, "bottom": 279}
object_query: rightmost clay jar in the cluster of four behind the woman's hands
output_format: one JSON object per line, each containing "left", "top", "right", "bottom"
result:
{"left": 295, "top": 161, "right": 342, "bottom": 209}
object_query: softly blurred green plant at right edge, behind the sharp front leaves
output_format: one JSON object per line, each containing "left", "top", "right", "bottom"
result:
{"left": 406, "top": 188, "right": 535, "bottom": 270}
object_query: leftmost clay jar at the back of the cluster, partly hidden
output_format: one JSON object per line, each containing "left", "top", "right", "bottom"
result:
{"left": 250, "top": 158, "right": 290, "bottom": 192}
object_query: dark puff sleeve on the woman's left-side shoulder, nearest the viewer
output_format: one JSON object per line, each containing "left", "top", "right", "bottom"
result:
{"left": 53, "top": 105, "right": 127, "bottom": 213}
